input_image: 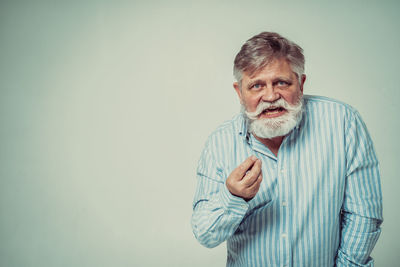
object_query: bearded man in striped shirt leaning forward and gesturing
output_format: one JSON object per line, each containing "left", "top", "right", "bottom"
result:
{"left": 192, "top": 32, "right": 382, "bottom": 267}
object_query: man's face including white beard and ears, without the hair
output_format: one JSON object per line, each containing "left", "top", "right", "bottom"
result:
{"left": 233, "top": 59, "right": 305, "bottom": 138}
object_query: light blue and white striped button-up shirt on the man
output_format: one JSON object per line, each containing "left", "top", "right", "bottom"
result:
{"left": 192, "top": 96, "right": 382, "bottom": 267}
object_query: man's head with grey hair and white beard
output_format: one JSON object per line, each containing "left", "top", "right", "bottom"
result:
{"left": 233, "top": 32, "right": 306, "bottom": 138}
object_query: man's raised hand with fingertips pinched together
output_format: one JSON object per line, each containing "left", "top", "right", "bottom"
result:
{"left": 226, "top": 156, "right": 262, "bottom": 201}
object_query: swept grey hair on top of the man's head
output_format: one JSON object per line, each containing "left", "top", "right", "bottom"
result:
{"left": 233, "top": 32, "right": 304, "bottom": 84}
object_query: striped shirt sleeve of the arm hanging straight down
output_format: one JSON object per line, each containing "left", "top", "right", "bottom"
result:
{"left": 336, "top": 111, "right": 383, "bottom": 267}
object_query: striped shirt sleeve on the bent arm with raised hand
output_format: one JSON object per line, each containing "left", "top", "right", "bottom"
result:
{"left": 192, "top": 140, "right": 249, "bottom": 248}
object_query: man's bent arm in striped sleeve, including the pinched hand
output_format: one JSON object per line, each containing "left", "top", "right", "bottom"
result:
{"left": 192, "top": 149, "right": 262, "bottom": 248}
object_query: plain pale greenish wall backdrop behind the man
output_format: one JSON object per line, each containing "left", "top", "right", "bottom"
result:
{"left": 0, "top": 1, "right": 400, "bottom": 267}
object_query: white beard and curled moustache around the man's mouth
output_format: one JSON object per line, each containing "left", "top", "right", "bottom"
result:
{"left": 242, "top": 96, "right": 304, "bottom": 139}
